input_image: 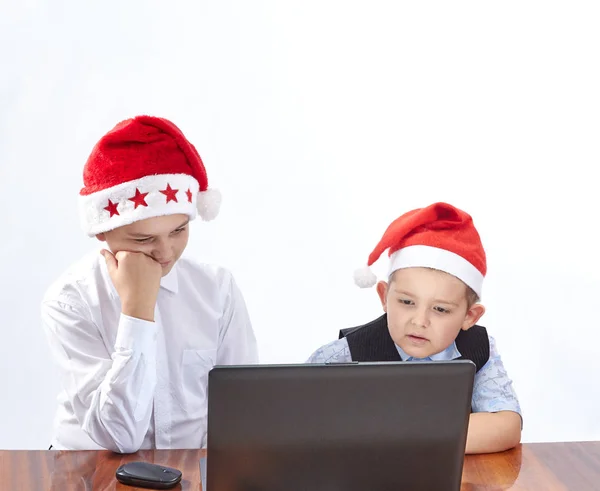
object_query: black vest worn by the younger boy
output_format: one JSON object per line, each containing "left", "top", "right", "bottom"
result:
{"left": 340, "top": 314, "right": 490, "bottom": 371}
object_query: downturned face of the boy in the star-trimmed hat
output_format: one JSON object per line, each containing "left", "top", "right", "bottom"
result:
{"left": 96, "top": 214, "right": 189, "bottom": 276}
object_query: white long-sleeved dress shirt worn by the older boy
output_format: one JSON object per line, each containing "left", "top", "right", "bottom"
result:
{"left": 42, "top": 252, "right": 258, "bottom": 453}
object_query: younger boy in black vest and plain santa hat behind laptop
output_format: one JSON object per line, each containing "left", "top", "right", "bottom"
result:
{"left": 309, "top": 203, "right": 521, "bottom": 453}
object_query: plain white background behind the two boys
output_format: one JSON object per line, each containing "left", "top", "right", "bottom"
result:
{"left": 0, "top": 0, "right": 600, "bottom": 448}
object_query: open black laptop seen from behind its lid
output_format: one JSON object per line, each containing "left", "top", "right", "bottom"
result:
{"left": 203, "top": 360, "right": 475, "bottom": 491}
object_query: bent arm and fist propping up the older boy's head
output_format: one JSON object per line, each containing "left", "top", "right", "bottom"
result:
{"left": 42, "top": 250, "right": 162, "bottom": 453}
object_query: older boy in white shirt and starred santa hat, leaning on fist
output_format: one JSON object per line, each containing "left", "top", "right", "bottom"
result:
{"left": 42, "top": 116, "right": 258, "bottom": 453}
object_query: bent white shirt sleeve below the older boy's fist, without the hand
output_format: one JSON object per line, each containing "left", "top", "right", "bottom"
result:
{"left": 42, "top": 299, "right": 156, "bottom": 453}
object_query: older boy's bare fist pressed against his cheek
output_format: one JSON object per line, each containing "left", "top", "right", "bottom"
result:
{"left": 102, "top": 250, "right": 162, "bottom": 322}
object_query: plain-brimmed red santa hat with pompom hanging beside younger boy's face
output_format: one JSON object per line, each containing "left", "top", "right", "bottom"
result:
{"left": 354, "top": 203, "right": 487, "bottom": 296}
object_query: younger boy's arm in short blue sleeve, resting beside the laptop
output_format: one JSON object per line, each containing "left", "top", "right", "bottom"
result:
{"left": 465, "top": 336, "right": 522, "bottom": 454}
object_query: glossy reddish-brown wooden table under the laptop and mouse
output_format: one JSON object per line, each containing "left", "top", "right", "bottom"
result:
{"left": 0, "top": 442, "right": 600, "bottom": 491}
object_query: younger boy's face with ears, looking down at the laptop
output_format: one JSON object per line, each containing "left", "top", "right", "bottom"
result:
{"left": 377, "top": 268, "right": 485, "bottom": 358}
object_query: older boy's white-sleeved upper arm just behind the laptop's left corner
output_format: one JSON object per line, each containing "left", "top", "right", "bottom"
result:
{"left": 217, "top": 273, "right": 258, "bottom": 365}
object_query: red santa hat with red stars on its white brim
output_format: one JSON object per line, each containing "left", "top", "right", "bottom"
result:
{"left": 79, "top": 116, "right": 221, "bottom": 236}
